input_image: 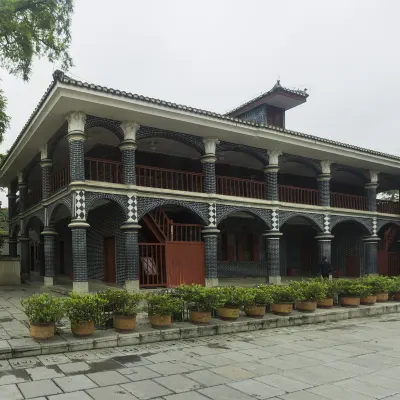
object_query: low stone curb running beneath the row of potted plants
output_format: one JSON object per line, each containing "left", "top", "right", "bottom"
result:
{"left": 0, "top": 301, "right": 400, "bottom": 360}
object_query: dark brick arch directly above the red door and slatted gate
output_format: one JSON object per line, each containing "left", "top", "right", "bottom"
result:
{"left": 137, "top": 197, "right": 209, "bottom": 226}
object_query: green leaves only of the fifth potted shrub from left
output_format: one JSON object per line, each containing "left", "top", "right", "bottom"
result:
{"left": 175, "top": 285, "right": 226, "bottom": 311}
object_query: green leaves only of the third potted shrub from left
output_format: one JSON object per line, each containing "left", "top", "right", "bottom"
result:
{"left": 98, "top": 289, "right": 143, "bottom": 317}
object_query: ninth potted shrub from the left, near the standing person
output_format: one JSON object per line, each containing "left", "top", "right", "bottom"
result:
{"left": 289, "top": 279, "right": 327, "bottom": 312}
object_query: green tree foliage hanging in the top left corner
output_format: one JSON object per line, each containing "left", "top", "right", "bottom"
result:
{"left": 0, "top": 0, "right": 73, "bottom": 142}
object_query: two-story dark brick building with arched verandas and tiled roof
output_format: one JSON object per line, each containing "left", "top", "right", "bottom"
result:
{"left": 0, "top": 71, "right": 400, "bottom": 291}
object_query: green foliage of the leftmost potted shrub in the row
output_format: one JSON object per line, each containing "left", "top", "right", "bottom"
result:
{"left": 21, "top": 293, "right": 64, "bottom": 324}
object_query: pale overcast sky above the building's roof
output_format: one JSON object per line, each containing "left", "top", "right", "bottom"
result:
{"left": 1, "top": 0, "right": 400, "bottom": 202}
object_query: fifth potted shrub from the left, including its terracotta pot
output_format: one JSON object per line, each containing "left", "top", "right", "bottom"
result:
{"left": 175, "top": 285, "right": 225, "bottom": 324}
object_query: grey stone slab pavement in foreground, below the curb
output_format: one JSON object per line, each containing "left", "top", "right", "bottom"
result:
{"left": 0, "top": 314, "right": 400, "bottom": 400}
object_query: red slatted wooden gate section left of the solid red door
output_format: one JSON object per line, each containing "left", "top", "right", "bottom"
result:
{"left": 139, "top": 243, "right": 167, "bottom": 287}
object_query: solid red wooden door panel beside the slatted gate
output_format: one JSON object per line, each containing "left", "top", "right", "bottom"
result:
{"left": 165, "top": 242, "right": 205, "bottom": 287}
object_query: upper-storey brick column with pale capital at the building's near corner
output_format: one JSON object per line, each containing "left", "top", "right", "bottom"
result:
{"left": 67, "top": 111, "right": 86, "bottom": 182}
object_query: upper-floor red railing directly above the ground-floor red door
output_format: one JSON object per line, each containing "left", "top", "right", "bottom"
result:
{"left": 136, "top": 165, "right": 203, "bottom": 192}
